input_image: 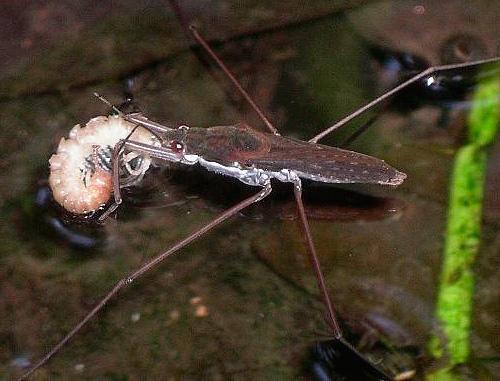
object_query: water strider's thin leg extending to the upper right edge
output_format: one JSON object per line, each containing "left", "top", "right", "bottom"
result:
{"left": 309, "top": 57, "right": 500, "bottom": 143}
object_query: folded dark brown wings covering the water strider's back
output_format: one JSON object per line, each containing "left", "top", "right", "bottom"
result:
{"left": 185, "top": 124, "right": 406, "bottom": 185}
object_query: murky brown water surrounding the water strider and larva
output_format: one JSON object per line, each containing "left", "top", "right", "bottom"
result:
{"left": 0, "top": 1, "right": 500, "bottom": 379}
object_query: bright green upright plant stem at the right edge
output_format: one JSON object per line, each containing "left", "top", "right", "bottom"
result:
{"left": 428, "top": 74, "right": 500, "bottom": 380}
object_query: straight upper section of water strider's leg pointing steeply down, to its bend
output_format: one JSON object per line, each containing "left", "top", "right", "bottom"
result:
{"left": 294, "top": 183, "right": 342, "bottom": 339}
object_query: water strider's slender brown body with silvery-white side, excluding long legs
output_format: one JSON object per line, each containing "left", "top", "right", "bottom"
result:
{"left": 123, "top": 114, "right": 406, "bottom": 190}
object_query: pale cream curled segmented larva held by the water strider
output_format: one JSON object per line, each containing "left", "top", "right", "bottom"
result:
{"left": 49, "top": 116, "right": 157, "bottom": 214}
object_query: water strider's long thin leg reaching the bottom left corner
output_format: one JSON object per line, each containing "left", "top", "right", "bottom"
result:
{"left": 19, "top": 182, "right": 272, "bottom": 380}
